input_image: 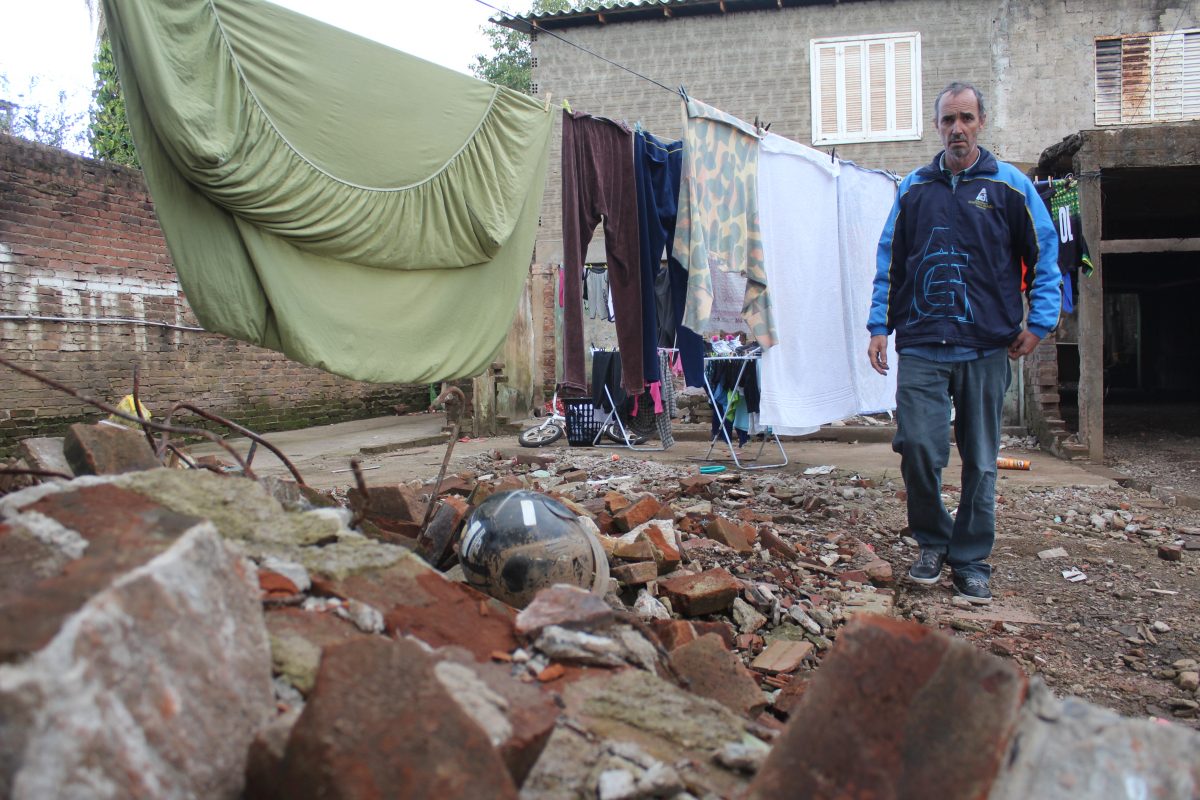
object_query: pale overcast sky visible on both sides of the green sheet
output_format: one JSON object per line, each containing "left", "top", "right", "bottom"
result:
{"left": 0, "top": 0, "right": 530, "bottom": 148}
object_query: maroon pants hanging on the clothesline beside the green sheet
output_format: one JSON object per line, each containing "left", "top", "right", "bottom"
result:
{"left": 563, "top": 110, "right": 644, "bottom": 396}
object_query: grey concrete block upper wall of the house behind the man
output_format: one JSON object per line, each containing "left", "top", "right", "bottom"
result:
{"left": 533, "top": 0, "right": 1200, "bottom": 263}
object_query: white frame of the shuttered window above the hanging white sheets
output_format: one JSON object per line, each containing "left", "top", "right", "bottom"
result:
{"left": 809, "top": 31, "right": 924, "bottom": 146}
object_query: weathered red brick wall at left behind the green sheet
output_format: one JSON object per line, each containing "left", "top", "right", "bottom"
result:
{"left": 0, "top": 136, "right": 428, "bottom": 452}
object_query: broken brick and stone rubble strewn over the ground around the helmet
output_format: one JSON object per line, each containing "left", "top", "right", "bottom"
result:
{"left": 0, "top": 426, "right": 1200, "bottom": 800}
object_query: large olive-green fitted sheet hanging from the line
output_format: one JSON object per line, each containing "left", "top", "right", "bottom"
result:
{"left": 103, "top": 0, "right": 553, "bottom": 384}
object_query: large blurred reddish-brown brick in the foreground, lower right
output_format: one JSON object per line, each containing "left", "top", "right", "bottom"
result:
{"left": 748, "top": 616, "right": 1027, "bottom": 800}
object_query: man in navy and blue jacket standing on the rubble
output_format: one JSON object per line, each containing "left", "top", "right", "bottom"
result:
{"left": 866, "top": 83, "right": 1062, "bottom": 603}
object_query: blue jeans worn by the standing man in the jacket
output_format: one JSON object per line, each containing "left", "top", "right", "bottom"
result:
{"left": 892, "top": 350, "right": 1012, "bottom": 578}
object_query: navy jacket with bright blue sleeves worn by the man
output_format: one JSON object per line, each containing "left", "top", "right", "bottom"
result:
{"left": 866, "top": 148, "right": 1062, "bottom": 350}
